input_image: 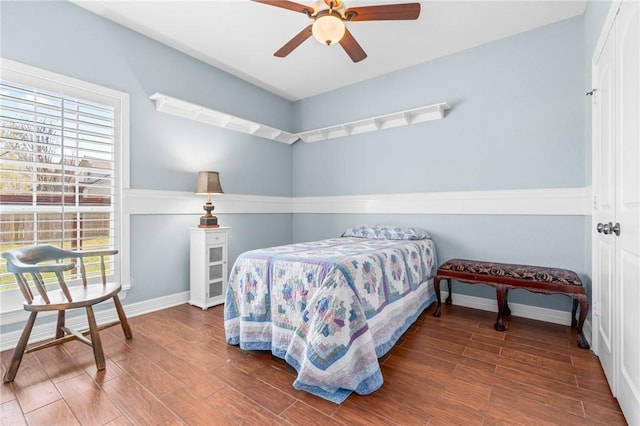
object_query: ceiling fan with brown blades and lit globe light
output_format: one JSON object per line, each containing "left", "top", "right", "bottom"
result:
{"left": 253, "top": 0, "right": 420, "bottom": 62}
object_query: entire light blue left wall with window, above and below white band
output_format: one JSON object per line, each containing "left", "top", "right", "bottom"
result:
{"left": 0, "top": 1, "right": 293, "bottom": 316}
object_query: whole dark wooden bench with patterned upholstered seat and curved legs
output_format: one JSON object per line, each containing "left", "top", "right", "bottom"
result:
{"left": 433, "top": 259, "right": 589, "bottom": 349}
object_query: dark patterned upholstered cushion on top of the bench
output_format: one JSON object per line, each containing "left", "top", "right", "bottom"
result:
{"left": 438, "top": 259, "right": 582, "bottom": 287}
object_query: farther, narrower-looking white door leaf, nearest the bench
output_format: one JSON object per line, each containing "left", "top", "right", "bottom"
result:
{"left": 591, "top": 12, "right": 616, "bottom": 391}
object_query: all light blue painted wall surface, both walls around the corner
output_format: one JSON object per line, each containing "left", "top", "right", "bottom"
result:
{"left": 0, "top": 1, "right": 608, "bottom": 322}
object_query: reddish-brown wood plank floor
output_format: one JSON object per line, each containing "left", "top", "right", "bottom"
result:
{"left": 0, "top": 305, "right": 625, "bottom": 426}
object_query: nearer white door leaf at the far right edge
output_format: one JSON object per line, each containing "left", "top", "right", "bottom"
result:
{"left": 615, "top": 1, "right": 640, "bottom": 424}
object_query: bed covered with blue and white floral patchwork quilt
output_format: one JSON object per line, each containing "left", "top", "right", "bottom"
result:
{"left": 224, "top": 226, "right": 437, "bottom": 404}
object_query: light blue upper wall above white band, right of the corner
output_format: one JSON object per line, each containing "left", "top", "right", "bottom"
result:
{"left": 293, "top": 17, "right": 587, "bottom": 196}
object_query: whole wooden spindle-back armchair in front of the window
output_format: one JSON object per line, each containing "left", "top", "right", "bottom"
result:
{"left": 2, "top": 245, "right": 132, "bottom": 383}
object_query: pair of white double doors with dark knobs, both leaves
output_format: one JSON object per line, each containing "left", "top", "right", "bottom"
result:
{"left": 592, "top": 1, "right": 640, "bottom": 425}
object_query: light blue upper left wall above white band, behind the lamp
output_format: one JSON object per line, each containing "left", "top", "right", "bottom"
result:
{"left": 1, "top": 1, "right": 292, "bottom": 196}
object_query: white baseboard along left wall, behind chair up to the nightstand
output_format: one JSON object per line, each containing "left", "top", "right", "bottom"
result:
{"left": 0, "top": 291, "right": 189, "bottom": 351}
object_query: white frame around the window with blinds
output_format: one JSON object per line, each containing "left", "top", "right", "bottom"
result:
{"left": 0, "top": 57, "right": 130, "bottom": 314}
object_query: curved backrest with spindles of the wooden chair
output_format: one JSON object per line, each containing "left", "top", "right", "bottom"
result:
{"left": 2, "top": 245, "right": 118, "bottom": 304}
